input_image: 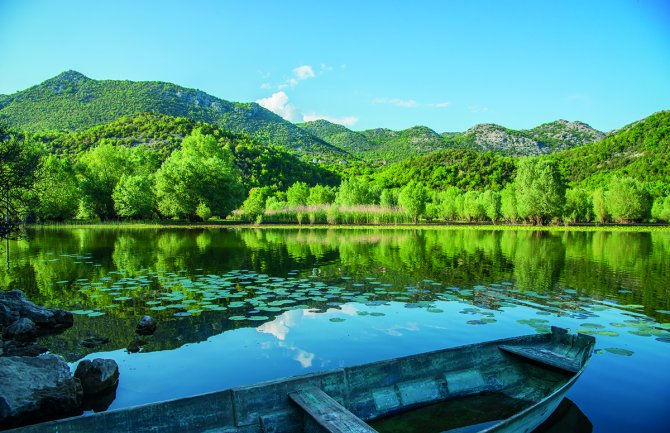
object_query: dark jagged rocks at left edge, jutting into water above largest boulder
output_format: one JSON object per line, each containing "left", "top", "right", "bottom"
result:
{"left": 0, "top": 290, "right": 73, "bottom": 332}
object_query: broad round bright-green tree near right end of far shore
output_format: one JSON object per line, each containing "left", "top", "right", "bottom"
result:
{"left": 605, "top": 177, "right": 651, "bottom": 222}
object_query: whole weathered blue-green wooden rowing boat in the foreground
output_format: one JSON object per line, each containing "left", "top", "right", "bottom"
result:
{"left": 11, "top": 327, "right": 595, "bottom": 433}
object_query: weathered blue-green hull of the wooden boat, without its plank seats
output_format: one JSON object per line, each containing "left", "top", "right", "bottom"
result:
{"left": 5, "top": 328, "right": 594, "bottom": 433}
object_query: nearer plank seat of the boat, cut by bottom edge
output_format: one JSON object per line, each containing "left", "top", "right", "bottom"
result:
{"left": 289, "top": 386, "right": 377, "bottom": 433}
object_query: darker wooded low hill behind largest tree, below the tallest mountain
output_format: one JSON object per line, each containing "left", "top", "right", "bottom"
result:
{"left": 33, "top": 113, "right": 340, "bottom": 189}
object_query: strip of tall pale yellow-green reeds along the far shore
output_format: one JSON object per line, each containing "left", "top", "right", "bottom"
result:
{"left": 262, "top": 204, "right": 412, "bottom": 225}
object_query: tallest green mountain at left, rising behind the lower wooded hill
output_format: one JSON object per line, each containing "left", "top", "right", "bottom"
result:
{"left": 0, "top": 71, "right": 347, "bottom": 160}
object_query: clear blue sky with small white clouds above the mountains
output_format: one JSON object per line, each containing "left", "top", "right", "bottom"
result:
{"left": 0, "top": 0, "right": 670, "bottom": 132}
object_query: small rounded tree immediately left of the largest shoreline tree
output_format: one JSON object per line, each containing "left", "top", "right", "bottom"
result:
{"left": 112, "top": 174, "right": 156, "bottom": 219}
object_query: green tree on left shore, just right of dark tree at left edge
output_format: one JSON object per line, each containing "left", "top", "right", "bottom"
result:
{"left": 35, "top": 155, "right": 81, "bottom": 221}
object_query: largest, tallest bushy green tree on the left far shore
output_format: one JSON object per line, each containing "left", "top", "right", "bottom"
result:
{"left": 156, "top": 129, "right": 243, "bottom": 219}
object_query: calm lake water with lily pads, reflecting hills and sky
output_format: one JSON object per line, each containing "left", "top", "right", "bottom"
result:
{"left": 0, "top": 229, "right": 670, "bottom": 432}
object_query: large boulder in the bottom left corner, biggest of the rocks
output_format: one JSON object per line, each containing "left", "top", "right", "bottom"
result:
{"left": 0, "top": 355, "right": 83, "bottom": 429}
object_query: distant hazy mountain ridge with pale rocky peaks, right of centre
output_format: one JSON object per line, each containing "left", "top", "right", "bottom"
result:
{"left": 298, "top": 116, "right": 605, "bottom": 162}
